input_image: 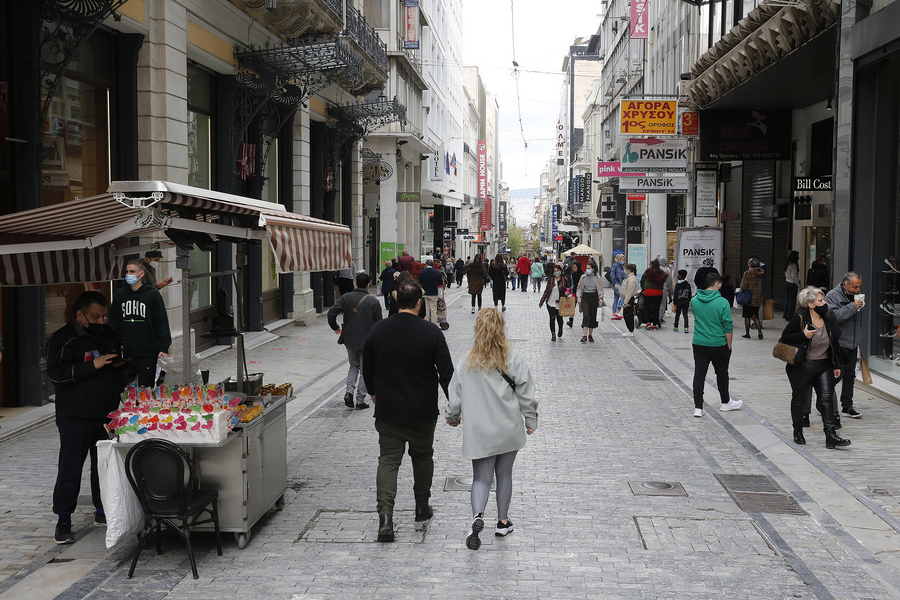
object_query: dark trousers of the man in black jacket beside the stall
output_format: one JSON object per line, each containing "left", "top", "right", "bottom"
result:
{"left": 53, "top": 417, "right": 109, "bottom": 517}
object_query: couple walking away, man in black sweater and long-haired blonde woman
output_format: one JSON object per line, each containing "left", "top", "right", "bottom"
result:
{"left": 363, "top": 281, "right": 537, "bottom": 550}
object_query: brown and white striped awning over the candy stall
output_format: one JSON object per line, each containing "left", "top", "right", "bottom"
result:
{"left": 0, "top": 181, "right": 350, "bottom": 285}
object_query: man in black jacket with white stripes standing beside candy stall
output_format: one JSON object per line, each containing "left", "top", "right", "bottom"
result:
{"left": 47, "top": 291, "right": 125, "bottom": 544}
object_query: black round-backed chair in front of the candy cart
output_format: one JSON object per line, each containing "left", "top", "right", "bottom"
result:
{"left": 125, "top": 439, "right": 222, "bottom": 579}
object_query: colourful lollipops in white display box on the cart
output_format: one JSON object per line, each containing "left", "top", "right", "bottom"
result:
{"left": 107, "top": 384, "right": 246, "bottom": 443}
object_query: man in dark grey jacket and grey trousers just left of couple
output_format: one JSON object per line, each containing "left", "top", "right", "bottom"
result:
{"left": 328, "top": 272, "right": 381, "bottom": 410}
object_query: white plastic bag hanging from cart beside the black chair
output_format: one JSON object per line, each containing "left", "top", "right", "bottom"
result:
{"left": 97, "top": 440, "right": 144, "bottom": 550}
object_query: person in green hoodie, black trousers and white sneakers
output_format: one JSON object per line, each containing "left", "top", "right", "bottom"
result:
{"left": 691, "top": 273, "right": 743, "bottom": 417}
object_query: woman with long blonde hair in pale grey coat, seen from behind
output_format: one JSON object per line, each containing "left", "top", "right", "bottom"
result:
{"left": 446, "top": 308, "right": 538, "bottom": 550}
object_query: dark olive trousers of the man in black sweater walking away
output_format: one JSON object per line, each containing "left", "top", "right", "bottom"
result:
{"left": 375, "top": 419, "right": 437, "bottom": 515}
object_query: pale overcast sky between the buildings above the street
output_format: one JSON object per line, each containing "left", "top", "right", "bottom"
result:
{"left": 463, "top": 0, "right": 601, "bottom": 195}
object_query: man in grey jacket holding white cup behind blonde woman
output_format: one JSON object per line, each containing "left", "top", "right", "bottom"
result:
{"left": 825, "top": 271, "right": 866, "bottom": 419}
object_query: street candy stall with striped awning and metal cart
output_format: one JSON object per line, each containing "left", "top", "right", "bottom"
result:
{"left": 0, "top": 181, "right": 350, "bottom": 548}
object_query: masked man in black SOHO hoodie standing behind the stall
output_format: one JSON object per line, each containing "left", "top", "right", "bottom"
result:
{"left": 109, "top": 259, "right": 172, "bottom": 387}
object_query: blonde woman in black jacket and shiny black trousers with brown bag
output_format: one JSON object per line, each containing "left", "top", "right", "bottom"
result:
{"left": 780, "top": 287, "right": 853, "bottom": 448}
